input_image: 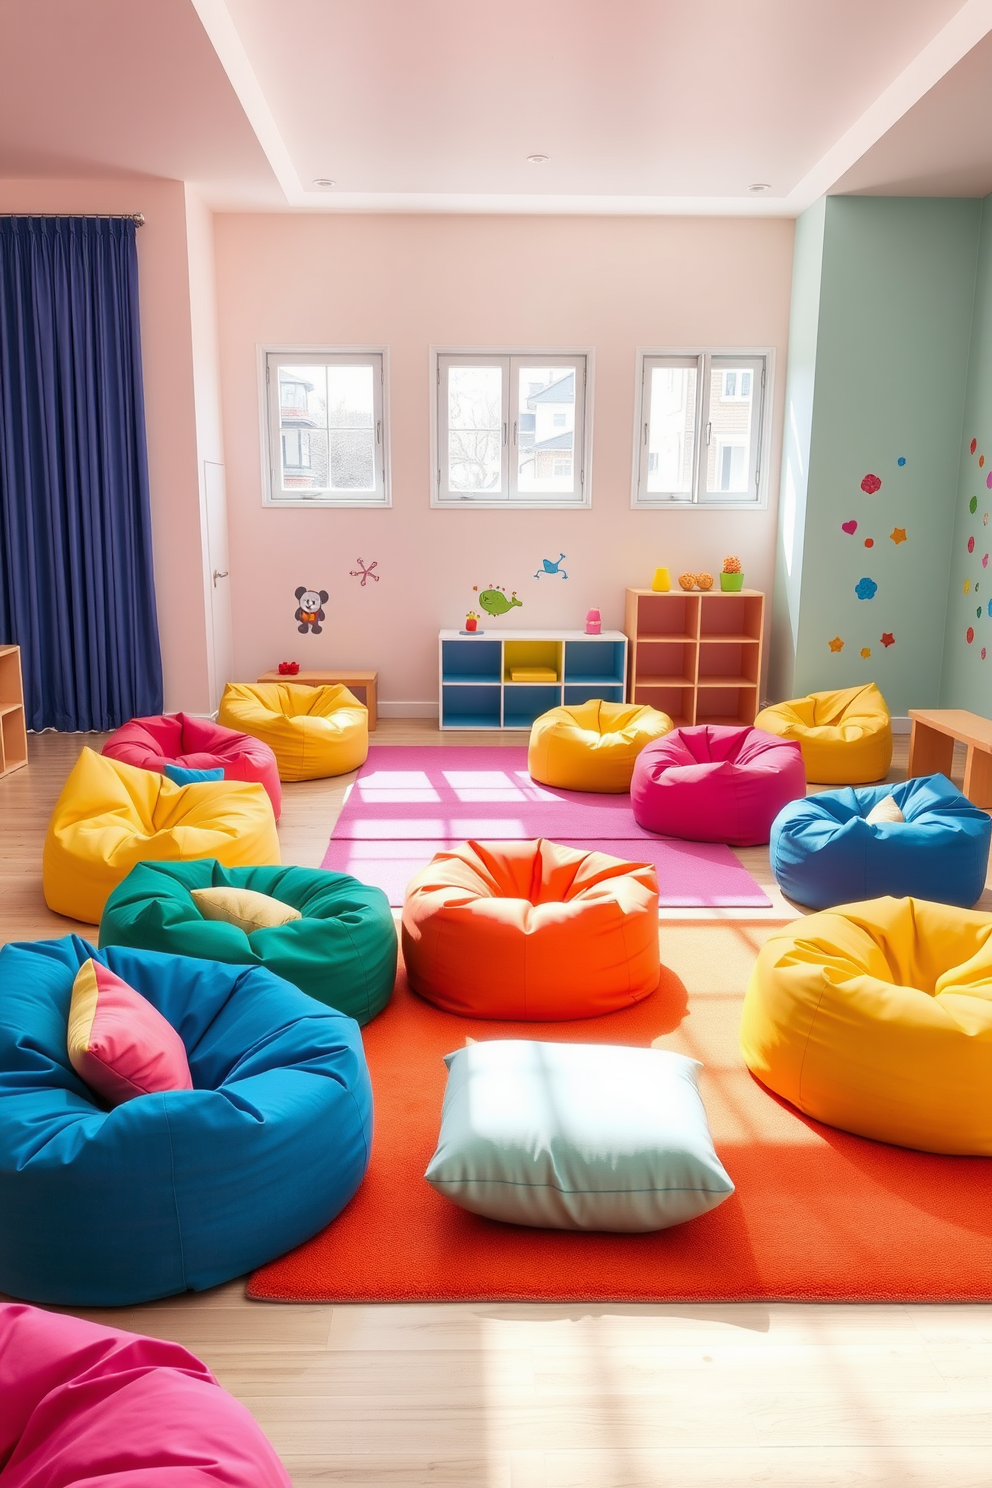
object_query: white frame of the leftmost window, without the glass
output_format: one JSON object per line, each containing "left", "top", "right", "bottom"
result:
{"left": 257, "top": 344, "right": 393, "bottom": 510}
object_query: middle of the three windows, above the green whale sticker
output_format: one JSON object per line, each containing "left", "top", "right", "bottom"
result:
{"left": 431, "top": 353, "right": 589, "bottom": 506}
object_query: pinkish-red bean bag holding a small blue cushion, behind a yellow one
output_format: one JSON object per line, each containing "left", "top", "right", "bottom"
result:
{"left": 103, "top": 713, "right": 283, "bottom": 820}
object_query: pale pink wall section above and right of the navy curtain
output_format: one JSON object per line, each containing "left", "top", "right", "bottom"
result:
{"left": 0, "top": 177, "right": 210, "bottom": 713}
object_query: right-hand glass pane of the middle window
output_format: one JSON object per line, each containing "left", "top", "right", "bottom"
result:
{"left": 516, "top": 366, "right": 576, "bottom": 496}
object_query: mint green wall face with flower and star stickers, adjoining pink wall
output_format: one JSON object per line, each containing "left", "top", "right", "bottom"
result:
{"left": 770, "top": 196, "right": 992, "bottom": 714}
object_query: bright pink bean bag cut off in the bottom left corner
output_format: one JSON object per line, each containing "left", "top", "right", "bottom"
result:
{"left": 0, "top": 1302, "right": 290, "bottom": 1488}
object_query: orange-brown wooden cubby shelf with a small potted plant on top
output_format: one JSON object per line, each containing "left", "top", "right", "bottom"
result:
{"left": 626, "top": 589, "right": 764, "bottom": 728}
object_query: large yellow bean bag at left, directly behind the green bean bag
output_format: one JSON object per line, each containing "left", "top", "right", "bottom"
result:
{"left": 42, "top": 748, "right": 280, "bottom": 924}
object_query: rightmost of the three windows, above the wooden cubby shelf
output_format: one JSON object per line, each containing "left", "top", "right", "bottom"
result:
{"left": 632, "top": 351, "right": 767, "bottom": 506}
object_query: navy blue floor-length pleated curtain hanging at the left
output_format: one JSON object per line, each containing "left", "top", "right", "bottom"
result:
{"left": 0, "top": 217, "right": 162, "bottom": 731}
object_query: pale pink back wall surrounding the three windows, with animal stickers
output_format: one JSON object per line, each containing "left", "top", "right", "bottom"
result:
{"left": 214, "top": 214, "right": 793, "bottom": 711}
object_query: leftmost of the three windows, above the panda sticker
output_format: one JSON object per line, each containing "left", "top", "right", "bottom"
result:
{"left": 263, "top": 350, "right": 390, "bottom": 506}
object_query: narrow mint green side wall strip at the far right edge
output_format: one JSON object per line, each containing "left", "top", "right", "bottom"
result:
{"left": 940, "top": 196, "right": 992, "bottom": 717}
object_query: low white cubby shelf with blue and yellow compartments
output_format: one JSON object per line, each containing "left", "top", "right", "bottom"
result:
{"left": 437, "top": 629, "right": 628, "bottom": 729}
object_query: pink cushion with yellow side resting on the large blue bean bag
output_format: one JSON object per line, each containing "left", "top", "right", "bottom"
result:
{"left": 67, "top": 958, "right": 193, "bottom": 1106}
